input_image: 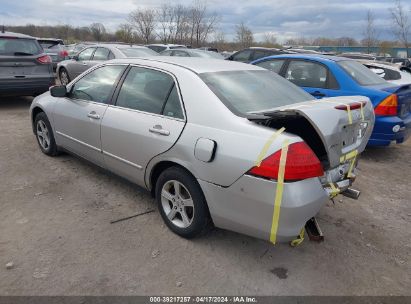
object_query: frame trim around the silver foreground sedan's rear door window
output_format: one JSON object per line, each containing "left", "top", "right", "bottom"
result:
{"left": 109, "top": 63, "right": 187, "bottom": 122}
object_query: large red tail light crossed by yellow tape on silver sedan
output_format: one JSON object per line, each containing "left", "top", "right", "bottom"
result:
{"left": 248, "top": 142, "right": 324, "bottom": 181}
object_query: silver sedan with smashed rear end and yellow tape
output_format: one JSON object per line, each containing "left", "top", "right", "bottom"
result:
{"left": 30, "top": 57, "right": 374, "bottom": 243}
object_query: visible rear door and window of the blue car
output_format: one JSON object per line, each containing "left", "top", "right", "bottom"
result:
{"left": 284, "top": 60, "right": 341, "bottom": 99}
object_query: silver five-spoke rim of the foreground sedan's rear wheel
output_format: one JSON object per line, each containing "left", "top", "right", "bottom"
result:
{"left": 161, "top": 180, "right": 194, "bottom": 228}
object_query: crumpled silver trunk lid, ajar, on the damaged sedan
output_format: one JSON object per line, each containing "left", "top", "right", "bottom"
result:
{"left": 249, "top": 96, "right": 375, "bottom": 170}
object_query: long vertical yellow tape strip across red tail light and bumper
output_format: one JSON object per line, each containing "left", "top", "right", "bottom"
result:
{"left": 270, "top": 139, "right": 290, "bottom": 244}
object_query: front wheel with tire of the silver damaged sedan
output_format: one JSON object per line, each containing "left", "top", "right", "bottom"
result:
{"left": 34, "top": 112, "right": 59, "bottom": 156}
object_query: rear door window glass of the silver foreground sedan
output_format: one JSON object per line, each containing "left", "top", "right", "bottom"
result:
{"left": 116, "top": 67, "right": 181, "bottom": 118}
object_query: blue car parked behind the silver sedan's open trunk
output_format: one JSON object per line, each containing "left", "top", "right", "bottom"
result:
{"left": 251, "top": 54, "right": 411, "bottom": 146}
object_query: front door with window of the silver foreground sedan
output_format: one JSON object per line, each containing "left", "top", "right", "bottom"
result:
{"left": 53, "top": 65, "right": 126, "bottom": 166}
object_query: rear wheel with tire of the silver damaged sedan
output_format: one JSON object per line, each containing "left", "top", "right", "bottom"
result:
{"left": 155, "top": 167, "right": 212, "bottom": 239}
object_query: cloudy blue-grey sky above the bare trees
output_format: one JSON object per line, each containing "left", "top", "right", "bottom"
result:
{"left": 0, "top": 0, "right": 411, "bottom": 40}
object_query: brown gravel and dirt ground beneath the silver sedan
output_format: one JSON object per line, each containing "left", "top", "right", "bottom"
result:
{"left": 0, "top": 98, "right": 411, "bottom": 295}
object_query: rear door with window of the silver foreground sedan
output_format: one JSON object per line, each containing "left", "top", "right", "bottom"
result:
{"left": 101, "top": 66, "right": 185, "bottom": 185}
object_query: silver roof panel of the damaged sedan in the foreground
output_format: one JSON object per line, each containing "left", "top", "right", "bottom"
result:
{"left": 110, "top": 56, "right": 264, "bottom": 74}
